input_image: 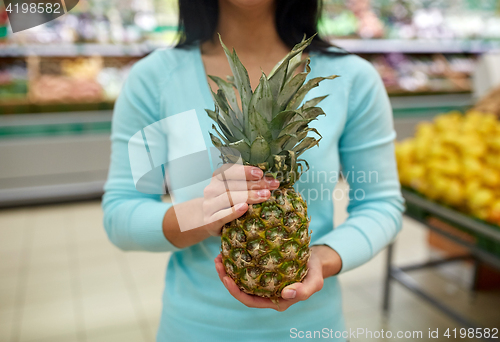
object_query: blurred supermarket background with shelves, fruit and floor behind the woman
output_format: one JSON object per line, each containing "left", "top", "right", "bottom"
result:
{"left": 0, "top": 0, "right": 500, "bottom": 342}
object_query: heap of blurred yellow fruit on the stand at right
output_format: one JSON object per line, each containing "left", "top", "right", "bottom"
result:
{"left": 402, "top": 110, "right": 500, "bottom": 221}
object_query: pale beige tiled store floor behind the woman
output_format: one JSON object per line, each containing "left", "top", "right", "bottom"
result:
{"left": 0, "top": 182, "right": 500, "bottom": 342}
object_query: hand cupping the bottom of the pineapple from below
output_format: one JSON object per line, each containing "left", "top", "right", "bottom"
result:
{"left": 214, "top": 246, "right": 342, "bottom": 311}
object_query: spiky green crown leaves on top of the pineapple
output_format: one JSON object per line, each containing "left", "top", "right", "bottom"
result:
{"left": 206, "top": 35, "right": 338, "bottom": 186}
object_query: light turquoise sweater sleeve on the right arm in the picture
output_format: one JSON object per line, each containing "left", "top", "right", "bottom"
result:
{"left": 314, "top": 60, "right": 404, "bottom": 273}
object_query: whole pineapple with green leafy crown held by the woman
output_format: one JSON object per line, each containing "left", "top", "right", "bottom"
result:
{"left": 207, "top": 37, "right": 337, "bottom": 303}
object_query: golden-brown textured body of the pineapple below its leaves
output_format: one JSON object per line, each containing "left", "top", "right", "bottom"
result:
{"left": 221, "top": 188, "right": 311, "bottom": 299}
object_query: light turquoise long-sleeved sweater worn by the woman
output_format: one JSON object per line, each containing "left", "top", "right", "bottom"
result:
{"left": 102, "top": 47, "right": 403, "bottom": 342}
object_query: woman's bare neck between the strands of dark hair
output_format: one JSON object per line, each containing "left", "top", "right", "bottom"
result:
{"left": 203, "top": 0, "right": 288, "bottom": 58}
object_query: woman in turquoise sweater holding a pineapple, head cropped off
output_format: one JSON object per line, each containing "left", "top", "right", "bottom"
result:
{"left": 103, "top": 0, "right": 403, "bottom": 341}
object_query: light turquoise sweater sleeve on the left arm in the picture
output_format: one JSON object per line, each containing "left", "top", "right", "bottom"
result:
{"left": 102, "top": 52, "right": 177, "bottom": 252}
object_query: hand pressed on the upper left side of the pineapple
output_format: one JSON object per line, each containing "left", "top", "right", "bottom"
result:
{"left": 203, "top": 164, "right": 280, "bottom": 236}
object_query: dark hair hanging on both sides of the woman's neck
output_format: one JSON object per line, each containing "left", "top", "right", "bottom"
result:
{"left": 176, "top": 0, "right": 347, "bottom": 54}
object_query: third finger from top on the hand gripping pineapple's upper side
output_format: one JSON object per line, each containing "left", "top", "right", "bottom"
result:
{"left": 204, "top": 190, "right": 271, "bottom": 215}
